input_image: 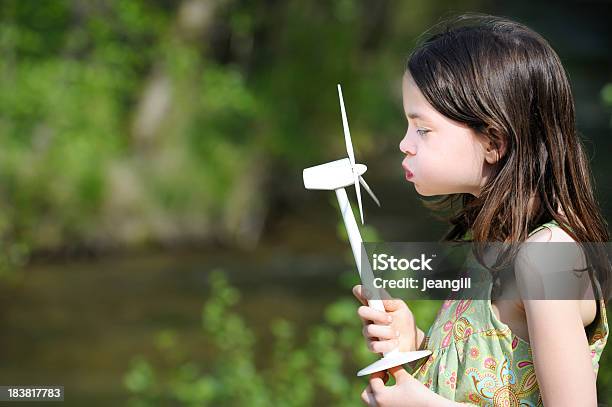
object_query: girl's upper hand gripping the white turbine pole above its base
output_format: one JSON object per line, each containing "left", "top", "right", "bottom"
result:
{"left": 353, "top": 285, "right": 419, "bottom": 353}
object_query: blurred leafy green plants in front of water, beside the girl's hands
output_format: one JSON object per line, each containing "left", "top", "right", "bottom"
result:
{"left": 124, "top": 271, "right": 440, "bottom": 406}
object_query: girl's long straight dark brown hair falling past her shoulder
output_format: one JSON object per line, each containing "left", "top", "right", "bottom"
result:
{"left": 406, "top": 14, "right": 610, "bottom": 299}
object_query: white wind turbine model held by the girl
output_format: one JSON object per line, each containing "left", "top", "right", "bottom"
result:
{"left": 303, "top": 84, "right": 431, "bottom": 376}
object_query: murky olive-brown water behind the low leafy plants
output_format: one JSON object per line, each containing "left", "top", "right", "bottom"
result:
{"left": 0, "top": 249, "right": 350, "bottom": 405}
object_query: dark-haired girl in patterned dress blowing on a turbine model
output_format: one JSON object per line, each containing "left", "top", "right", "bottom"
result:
{"left": 353, "top": 15, "right": 609, "bottom": 407}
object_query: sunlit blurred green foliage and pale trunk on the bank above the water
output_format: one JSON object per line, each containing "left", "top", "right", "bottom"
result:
{"left": 0, "top": 0, "right": 270, "bottom": 268}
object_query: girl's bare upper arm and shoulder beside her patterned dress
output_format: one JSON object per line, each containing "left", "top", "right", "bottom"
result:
{"left": 515, "top": 228, "right": 597, "bottom": 406}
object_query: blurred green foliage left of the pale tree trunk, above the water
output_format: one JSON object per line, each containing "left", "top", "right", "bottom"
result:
{"left": 0, "top": 1, "right": 166, "bottom": 264}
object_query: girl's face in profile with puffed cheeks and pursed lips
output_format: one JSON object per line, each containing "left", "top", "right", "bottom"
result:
{"left": 399, "top": 74, "right": 489, "bottom": 196}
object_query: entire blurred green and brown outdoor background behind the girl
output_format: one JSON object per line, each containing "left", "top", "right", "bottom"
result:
{"left": 0, "top": 0, "right": 612, "bottom": 406}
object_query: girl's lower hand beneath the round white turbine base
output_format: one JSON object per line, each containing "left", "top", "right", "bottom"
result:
{"left": 361, "top": 366, "right": 438, "bottom": 407}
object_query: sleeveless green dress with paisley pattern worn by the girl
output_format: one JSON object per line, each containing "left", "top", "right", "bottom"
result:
{"left": 412, "top": 221, "right": 608, "bottom": 407}
